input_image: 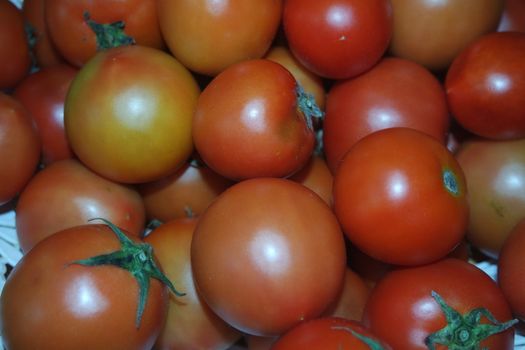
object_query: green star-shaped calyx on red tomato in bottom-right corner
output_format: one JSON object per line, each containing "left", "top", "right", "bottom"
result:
{"left": 425, "top": 291, "right": 518, "bottom": 350}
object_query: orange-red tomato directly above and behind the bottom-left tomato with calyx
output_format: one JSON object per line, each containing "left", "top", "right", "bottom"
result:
{"left": 15, "top": 159, "right": 145, "bottom": 252}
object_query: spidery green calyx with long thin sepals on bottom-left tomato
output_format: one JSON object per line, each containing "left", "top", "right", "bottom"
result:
{"left": 71, "top": 218, "right": 185, "bottom": 328}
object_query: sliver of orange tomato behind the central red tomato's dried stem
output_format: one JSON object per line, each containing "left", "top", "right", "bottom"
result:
{"left": 264, "top": 45, "right": 326, "bottom": 110}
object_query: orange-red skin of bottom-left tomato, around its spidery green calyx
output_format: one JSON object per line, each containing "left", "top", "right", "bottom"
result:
{"left": 0, "top": 224, "right": 168, "bottom": 350}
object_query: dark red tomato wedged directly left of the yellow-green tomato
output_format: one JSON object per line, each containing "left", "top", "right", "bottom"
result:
{"left": 13, "top": 64, "right": 77, "bottom": 164}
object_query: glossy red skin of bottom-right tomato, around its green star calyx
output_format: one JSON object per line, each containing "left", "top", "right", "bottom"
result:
{"left": 363, "top": 259, "right": 514, "bottom": 350}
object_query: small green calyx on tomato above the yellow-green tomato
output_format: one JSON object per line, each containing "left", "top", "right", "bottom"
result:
{"left": 84, "top": 11, "right": 135, "bottom": 51}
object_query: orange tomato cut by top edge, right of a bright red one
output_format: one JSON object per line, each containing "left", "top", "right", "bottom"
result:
{"left": 389, "top": 0, "right": 504, "bottom": 72}
